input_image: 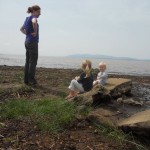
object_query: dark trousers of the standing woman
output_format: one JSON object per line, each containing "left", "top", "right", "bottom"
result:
{"left": 24, "top": 42, "right": 38, "bottom": 84}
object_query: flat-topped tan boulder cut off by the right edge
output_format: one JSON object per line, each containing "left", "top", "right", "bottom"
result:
{"left": 118, "top": 109, "right": 150, "bottom": 137}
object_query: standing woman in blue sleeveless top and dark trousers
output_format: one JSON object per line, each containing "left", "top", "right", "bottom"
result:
{"left": 20, "top": 5, "right": 41, "bottom": 85}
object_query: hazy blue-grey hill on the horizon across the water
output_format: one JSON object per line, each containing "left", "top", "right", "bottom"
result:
{"left": 66, "top": 54, "right": 138, "bottom": 60}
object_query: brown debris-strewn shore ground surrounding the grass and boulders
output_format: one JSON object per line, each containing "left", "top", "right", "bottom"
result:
{"left": 0, "top": 66, "right": 150, "bottom": 150}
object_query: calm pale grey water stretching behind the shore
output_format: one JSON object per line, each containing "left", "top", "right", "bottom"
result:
{"left": 0, "top": 54, "right": 150, "bottom": 76}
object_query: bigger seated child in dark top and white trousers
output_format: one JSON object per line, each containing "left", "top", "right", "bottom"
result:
{"left": 66, "top": 60, "right": 93, "bottom": 99}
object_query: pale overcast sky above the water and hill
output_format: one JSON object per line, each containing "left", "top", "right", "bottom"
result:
{"left": 0, "top": 0, "right": 150, "bottom": 59}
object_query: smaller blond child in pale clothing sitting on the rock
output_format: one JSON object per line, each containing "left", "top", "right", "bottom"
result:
{"left": 93, "top": 62, "right": 108, "bottom": 86}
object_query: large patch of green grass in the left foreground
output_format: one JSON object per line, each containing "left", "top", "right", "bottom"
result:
{"left": 0, "top": 98, "right": 76, "bottom": 132}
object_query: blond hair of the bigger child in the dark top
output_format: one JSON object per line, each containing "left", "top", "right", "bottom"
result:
{"left": 82, "top": 59, "right": 92, "bottom": 77}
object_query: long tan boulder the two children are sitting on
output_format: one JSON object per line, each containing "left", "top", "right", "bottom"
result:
{"left": 72, "top": 78, "right": 132, "bottom": 105}
